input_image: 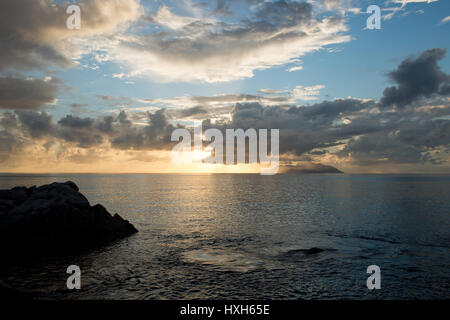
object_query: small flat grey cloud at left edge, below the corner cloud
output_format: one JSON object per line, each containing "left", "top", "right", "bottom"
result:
{"left": 0, "top": 77, "right": 61, "bottom": 110}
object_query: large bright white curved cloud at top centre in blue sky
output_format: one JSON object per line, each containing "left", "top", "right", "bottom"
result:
{"left": 103, "top": 1, "right": 350, "bottom": 82}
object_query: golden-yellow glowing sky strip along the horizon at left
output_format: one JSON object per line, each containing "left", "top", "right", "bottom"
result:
{"left": 2, "top": 148, "right": 260, "bottom": 174}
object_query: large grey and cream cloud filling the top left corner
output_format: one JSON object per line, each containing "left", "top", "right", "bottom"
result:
{"left": 0, "top": 0, "right": 140, "bottom": 72}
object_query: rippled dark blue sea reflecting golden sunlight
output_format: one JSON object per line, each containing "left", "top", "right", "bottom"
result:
{"left": 0, "top": 174, "right": 450, "bottom": 299}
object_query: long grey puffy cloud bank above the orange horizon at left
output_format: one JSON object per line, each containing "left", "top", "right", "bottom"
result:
{"left": 10, "top": 110, "right": 181, "bottom": 150}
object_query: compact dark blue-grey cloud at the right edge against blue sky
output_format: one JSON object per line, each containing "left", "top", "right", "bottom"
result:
{"left": 380, "top": 49, "right": 450, "bottom": 109}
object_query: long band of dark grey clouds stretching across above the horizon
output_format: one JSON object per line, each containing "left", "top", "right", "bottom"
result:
{"left": 0, "top": 94, "right": 450, "bottom": 168}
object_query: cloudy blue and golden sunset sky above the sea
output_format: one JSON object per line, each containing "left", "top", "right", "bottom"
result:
{"left": 0, "top": 0, "right": 450, "bottom": 173}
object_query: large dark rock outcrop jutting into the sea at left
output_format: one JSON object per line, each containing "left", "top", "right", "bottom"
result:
{"left": 0, "top": 181, "right": 137, "bottom": 257}
